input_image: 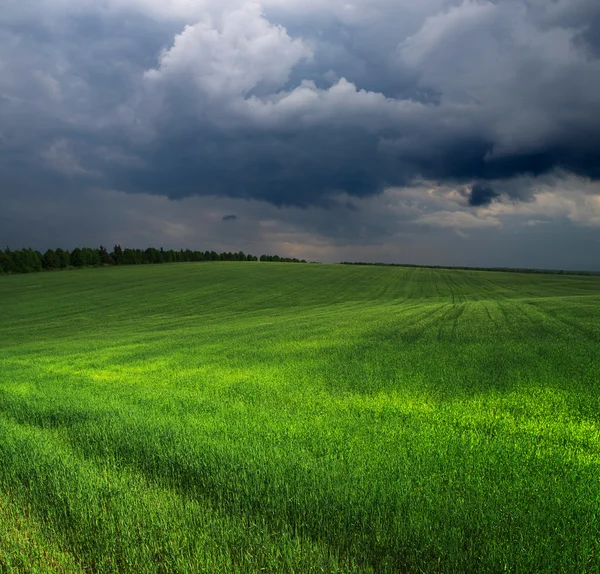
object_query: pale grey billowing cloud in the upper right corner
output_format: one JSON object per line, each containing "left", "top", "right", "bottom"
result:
{"left": 398, "top": 0, "right": 600, "bottom": 160}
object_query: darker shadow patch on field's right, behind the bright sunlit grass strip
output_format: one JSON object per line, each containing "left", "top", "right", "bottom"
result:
{"left": 308, "top": 303, "right": 600, "bottom": 401}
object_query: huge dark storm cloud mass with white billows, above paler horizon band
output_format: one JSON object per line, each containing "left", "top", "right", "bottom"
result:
{"left": 0, "top": 0, "right": 600, "bottom": 220}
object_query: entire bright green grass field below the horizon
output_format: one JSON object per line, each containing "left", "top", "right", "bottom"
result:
{"left": 0, "top": 263, "right": 600, "bottom": 573}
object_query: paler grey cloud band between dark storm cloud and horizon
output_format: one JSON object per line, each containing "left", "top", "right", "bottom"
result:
{"left": 0, "top": 184, "right": 600, "bottom": 269}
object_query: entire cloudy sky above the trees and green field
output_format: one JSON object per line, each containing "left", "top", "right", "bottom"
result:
{"left": 0, "top": 0, "right": 600, "bottom": 270}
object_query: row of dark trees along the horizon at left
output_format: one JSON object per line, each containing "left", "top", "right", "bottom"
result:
{"left": 0, "top": 245, "right": 306, "bottom": 274}
